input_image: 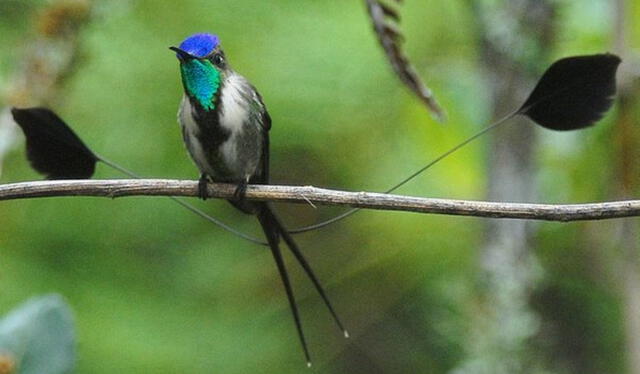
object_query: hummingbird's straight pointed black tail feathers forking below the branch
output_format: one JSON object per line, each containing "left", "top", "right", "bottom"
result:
{"left": 257, "top": 203, "right": 349, "bottom": 365}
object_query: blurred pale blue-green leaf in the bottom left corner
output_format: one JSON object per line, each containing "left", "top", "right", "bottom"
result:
{"left": 0, "top": 295, "right": 75, "bottom": 374}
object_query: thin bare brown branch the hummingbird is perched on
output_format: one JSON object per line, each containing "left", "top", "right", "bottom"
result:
{"left": 0, "top": 179, "right": 640, "bottom": 222}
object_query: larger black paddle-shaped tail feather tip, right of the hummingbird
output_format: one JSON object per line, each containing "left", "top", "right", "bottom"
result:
{"left": 518, "top": 53, "right": 622, "bottom": 131}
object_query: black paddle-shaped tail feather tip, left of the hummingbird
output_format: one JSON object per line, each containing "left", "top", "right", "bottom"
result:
{"left": 11, "top": 108, "right": 98, "bottom": 179}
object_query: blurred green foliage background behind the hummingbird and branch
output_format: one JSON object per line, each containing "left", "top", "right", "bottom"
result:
{"left": 0, "top": 0, "right": 640, "bottom": 373}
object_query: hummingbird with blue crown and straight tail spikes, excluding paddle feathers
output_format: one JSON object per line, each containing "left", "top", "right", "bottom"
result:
{"left": 170, "top": 33, "right": 348, "bottom": 365}
